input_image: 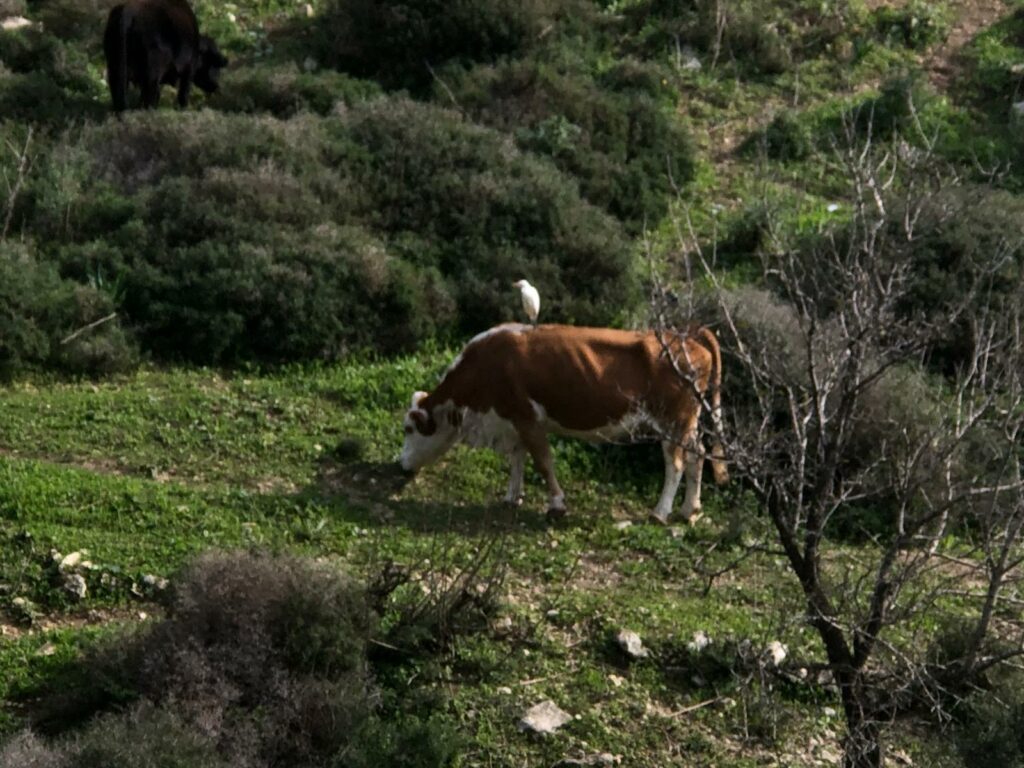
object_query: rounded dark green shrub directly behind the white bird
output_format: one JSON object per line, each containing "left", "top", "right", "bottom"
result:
{"left": 339, "top": 99, "right": 636, "bottom": 332}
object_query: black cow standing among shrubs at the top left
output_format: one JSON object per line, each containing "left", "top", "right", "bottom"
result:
{"left": 103, "top": 0, "right": 227, "bottom": 112}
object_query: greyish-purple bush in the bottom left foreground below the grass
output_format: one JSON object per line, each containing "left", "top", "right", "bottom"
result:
{"left": 18, "top": 553, "right": 459, "bottom": 768}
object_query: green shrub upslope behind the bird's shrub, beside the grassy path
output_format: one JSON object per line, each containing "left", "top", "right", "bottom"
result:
{"left": 450, "top": 59, "right": 694, "bottom": 229}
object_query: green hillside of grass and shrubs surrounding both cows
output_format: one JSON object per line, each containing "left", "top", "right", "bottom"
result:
{"left": 0, "top": 0, "right": 1024, "bottom": 768}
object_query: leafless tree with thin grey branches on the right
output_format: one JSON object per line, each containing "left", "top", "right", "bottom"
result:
{"left": 658, "top": 121, "right": 1024, "bottom": 768}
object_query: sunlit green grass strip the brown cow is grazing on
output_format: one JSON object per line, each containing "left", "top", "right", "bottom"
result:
{"left": 0, "top": 352, "right": 970, "bottom": 766}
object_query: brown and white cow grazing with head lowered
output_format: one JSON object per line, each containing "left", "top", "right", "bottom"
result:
{"left": 399, "top": 324, "right": 727, "bottom": 523}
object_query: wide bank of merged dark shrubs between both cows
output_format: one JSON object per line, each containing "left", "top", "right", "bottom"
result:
{"left": 6, "top": 102, "right": 637, "bottom": 371}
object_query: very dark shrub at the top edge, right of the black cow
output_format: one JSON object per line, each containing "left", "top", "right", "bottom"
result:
{"left": 321, "top": 0, "right": 557, "bottom": 88}
